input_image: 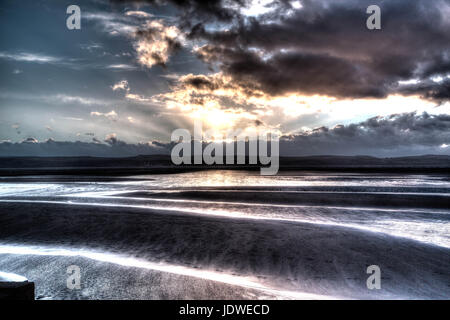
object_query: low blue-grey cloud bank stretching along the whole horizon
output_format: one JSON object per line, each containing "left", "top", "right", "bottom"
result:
{"left": 0, "top": 113, "right": 450, "bottom": 157}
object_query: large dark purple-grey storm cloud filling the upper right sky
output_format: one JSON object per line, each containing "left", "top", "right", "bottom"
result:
{"left": 185, "top": 0, "right": 450, "bottom": 100}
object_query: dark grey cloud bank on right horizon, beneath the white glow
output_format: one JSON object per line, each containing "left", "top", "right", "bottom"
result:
{"left": 280, "top": 112, "right": 450, "bottom": 155}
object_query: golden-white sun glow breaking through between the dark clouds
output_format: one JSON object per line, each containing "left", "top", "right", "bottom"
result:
{"left": 152, "top": 73, "right": 449, "bottom": 135}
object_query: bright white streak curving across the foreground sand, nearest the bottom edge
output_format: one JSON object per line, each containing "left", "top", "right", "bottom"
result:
{"left": 0, "top": 245, "right": 338, "bottom": 300}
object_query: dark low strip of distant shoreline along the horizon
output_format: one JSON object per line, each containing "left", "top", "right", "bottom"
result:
{"left": 0, "top": 155, "right": 450, "bottom": 176}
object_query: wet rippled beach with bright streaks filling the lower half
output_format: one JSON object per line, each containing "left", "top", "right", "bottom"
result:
{"left": 0, "top": 170, "right": 450, "bottom": 299}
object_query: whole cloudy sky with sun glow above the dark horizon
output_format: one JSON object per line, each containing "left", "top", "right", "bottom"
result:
{"left": 0, "top": 0, "right": 450, "bottom": 156}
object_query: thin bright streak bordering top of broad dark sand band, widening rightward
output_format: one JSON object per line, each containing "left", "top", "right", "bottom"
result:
{"left": 0, "top": 199, "right": 450, "bottom": 248}
